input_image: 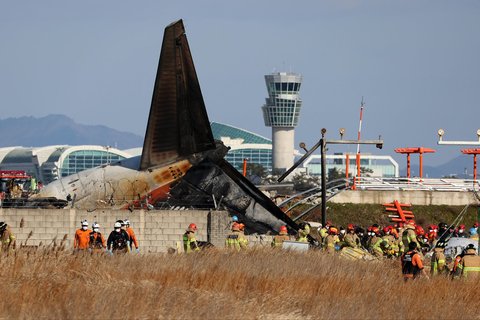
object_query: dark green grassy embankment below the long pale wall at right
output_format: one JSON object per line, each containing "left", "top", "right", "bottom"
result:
{"left": 290, "top": 203, "right": 478, "bottom": 230}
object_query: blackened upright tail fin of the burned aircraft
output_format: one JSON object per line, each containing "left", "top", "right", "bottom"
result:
{"left": 140, "top": 20, "right": 215, "bottom": 170}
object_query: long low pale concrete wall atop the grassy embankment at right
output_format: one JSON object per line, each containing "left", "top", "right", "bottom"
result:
{"left": 330, "top": 190, "right": 477, "bottom": 206}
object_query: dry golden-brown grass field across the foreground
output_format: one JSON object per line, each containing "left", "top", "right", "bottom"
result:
{"left": 0, "top": 249, "right": 479, "bottom": 319}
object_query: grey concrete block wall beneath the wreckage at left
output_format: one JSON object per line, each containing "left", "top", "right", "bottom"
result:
{"left": 0, "top": 209, "right": 230, "bottom": 253}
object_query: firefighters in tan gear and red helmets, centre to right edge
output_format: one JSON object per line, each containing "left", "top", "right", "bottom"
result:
{"left": 183, "top": 216, "right": 480, "bottom": 280}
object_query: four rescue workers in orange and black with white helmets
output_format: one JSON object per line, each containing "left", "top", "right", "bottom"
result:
{"left": 73, "top": 219, "right": 139, "bottom": 254}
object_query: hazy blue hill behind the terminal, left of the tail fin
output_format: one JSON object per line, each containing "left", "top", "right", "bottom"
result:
{"left": 0, "top": 115, "right": 143, "bottom": 149}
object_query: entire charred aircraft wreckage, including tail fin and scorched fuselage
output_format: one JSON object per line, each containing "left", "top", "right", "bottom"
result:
{"left": 29, "top": 20, "right": 308, "bottom": 233}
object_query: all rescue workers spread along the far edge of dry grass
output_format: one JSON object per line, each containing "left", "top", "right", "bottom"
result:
{"left": 0, "top": 211, "right": 480, "bottom": 280}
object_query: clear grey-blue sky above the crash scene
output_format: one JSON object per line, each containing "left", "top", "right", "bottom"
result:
{"left": 0, "top": 0, "right": 480, "bottom": 167}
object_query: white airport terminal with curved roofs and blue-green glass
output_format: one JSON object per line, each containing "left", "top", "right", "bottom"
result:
{"left": 0, "top": 122, "right": 399, "bottom": 184}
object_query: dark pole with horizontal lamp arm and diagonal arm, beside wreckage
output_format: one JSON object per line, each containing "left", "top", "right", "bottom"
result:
{"left": 277, "top": 128, "right": 383, "bottom": 225}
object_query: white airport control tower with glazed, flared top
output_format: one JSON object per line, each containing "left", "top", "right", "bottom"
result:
{"left": 262, "top": 72, "right": 302, "bottom": 172}
